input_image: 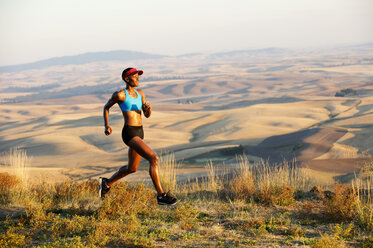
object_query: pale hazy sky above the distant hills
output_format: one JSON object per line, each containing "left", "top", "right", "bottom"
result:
{"left": 0, "top": 0, "right": 373, "bottom": 65}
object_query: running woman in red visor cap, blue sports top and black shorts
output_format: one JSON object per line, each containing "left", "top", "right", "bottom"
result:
{"left": 99, "top": 68, "right": 177, "bottom": 205}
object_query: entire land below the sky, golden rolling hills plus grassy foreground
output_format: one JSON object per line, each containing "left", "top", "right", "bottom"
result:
{"left": 0, "top": 45, "right": 373, "bottom": 247}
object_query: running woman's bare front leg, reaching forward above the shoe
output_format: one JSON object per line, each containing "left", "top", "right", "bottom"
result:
{"left": 128, "top": 136, "right": 164, "bottom": 195}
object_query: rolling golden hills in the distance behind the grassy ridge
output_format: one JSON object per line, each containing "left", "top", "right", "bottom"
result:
{"left": 0, "top": 45, "right": 373, "bottom": 181}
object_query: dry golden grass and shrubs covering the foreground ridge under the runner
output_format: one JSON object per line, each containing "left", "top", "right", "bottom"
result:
{"left": 0, "top": 149, "right": 372, "bottom": 247}
